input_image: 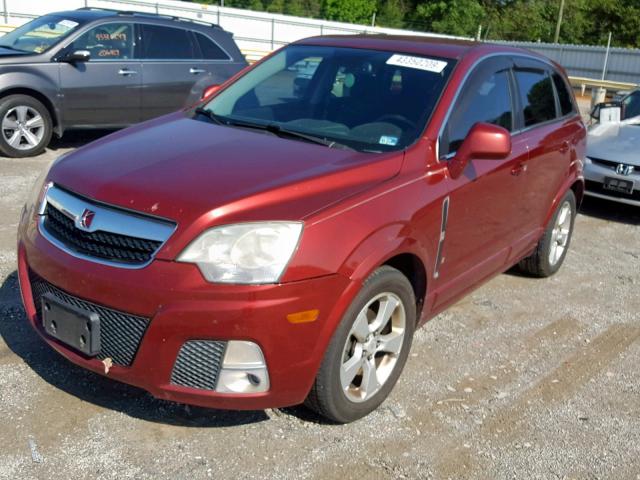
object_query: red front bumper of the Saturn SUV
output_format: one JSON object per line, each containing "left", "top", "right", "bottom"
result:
{"left": 18, "top": 221, "right": 357, "bottom": 409}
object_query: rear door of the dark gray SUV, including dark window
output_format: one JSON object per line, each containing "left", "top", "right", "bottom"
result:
{"left": 139, "top": 23, "right": 206, "bottom": 120}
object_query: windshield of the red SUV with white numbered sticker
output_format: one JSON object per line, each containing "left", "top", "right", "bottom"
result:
{"left": 200, "top": 45, "right": 454, "bottom": 152}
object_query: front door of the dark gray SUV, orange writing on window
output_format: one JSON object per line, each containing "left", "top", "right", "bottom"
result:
{"left": 59, "top": 22, "right": 142, "bottom": 127}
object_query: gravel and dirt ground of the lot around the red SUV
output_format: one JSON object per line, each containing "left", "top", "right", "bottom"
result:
{"left": 0, "top": 132, "right": 640, "bottom": 480}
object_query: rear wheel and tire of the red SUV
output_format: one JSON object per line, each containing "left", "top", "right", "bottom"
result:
{"left": 518, "top": 190, "right": 577, "bottom": 278}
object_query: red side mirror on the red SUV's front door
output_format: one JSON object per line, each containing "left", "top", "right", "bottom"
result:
{"left": 448, "top": 123, "right": 511, "bottom": 178}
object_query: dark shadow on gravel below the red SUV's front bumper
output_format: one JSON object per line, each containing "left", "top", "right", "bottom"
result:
{"left": 0, "top": 272, "right": 278, "bottom": 428}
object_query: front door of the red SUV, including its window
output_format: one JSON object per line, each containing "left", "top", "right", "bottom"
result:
{"left": 436, "top": 57, "right": 528, "bottom": 305}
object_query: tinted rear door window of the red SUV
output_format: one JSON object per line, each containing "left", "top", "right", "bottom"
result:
{"left": 516, "top": 70, "right": 556, "bottom": 127}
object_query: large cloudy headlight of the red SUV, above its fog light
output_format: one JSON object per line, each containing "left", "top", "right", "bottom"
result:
{"left": 178, "top": 222, "right": 302, "bottom": 283}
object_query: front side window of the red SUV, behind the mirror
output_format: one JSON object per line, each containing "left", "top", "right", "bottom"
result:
{"left": 440, "top": 70, "right": 513, "bottom": 156}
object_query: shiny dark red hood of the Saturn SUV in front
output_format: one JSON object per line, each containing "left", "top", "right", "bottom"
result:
{"left": 49, "top": 112, "right": 403, "bottom": 228}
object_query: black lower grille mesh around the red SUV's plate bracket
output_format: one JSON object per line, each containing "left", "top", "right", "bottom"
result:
{"left": 31, "top": 273, "right": 149, "bottom": 366}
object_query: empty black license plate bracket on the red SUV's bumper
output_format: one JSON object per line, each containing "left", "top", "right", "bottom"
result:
{"left": 41, "top": 293, "right": 100, "bottom": 357}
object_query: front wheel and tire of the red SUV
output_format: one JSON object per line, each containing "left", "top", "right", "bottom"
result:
{"left": 305, "top": 266, "right": 416, "bottom": 423}
